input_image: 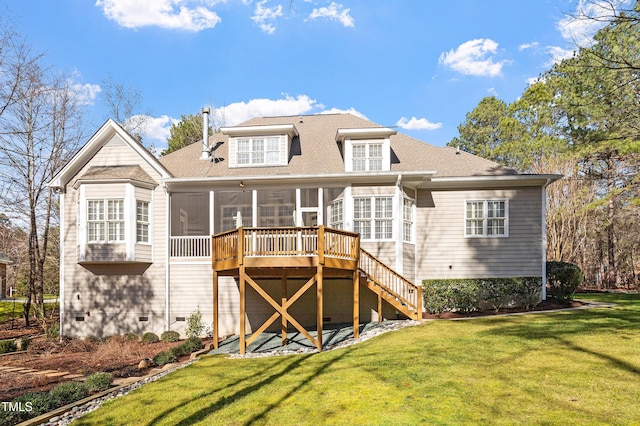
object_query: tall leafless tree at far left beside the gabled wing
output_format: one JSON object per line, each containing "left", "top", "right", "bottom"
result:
{"left": 0, "top": 31, "right": 81, "bottom": 325}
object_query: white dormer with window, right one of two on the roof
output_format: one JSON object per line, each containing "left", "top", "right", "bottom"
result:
{"left": 336, "top": 127, "right": 396, "bottom": 172}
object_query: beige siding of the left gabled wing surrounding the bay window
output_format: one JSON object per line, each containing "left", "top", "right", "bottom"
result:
{"left": 61, "top": 136, "right": 167, "bottom": 336}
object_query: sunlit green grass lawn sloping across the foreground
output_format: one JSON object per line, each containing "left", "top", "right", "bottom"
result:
{"left": 78, "top": 295, "right": 640, "bottom": 425}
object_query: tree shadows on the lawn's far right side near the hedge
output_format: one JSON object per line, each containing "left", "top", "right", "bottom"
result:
{"left": 482, "top": 308, "right": 640, "bottom": 375}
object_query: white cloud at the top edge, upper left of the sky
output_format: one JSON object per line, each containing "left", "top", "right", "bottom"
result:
{"left": 95, "top": 0, "right": 221, "bottom": 31}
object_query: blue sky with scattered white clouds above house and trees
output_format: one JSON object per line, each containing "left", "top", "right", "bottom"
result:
{"left": 0, "top": 0, "right": 608, "bottom": 148}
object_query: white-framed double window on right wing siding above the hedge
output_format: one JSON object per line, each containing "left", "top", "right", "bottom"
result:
{"left": 464, "top": 200, "right": 509, "bottom": 237}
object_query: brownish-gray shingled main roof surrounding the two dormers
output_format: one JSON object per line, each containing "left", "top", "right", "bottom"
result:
{"left": 160, "top": 114, "right": 518, "bottom": 178}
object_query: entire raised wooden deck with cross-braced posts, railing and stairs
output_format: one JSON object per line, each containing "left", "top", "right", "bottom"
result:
{"left": 211, "top": 226, "right": 422, "bottom": 354}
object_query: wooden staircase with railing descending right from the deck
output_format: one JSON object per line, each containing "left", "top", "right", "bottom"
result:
{"left": 358, "top": 248, "right": 422, "bottom": 321}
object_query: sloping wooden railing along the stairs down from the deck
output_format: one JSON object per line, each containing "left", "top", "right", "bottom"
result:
{"left": 360, "top": 249, "right": 422, "bottom": 319}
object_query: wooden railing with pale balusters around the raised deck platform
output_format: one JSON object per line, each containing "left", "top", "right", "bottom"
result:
{"left": 211, "top": 226, "right": 359, "bottom": 264}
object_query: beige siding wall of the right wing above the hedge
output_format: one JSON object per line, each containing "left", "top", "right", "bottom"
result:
{"left": 416, "top": 188, "right": 542, "bottom": 280}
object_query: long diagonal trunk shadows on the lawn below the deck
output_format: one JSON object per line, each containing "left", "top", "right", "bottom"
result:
{"left": 149, "top": 348, "right": 350, "bottom": 426}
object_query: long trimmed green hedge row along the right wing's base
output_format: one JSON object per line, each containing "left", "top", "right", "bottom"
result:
{"left": 422, "top": 277, "right": 542, "bottom": 314}
